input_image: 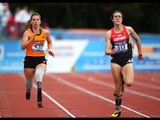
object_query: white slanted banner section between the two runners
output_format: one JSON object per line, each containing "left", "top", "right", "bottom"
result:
{"left": 46, "top": 39, "right": 88, "bottom": 73}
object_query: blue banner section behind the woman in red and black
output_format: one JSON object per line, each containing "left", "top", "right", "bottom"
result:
{"left": 74, "top": 41, "right": 160, "bottom": 72}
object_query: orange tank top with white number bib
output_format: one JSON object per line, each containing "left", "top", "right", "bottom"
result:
{"left": 26, "top": 29, "right": 46, "bottom": 57}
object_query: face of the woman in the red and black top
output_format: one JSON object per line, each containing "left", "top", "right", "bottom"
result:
{"left": 112, "top": 12, "right": 122, "bottom": 25}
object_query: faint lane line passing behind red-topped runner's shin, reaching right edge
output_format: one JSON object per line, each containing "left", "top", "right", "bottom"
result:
{"left": 70, "top": 73, "right": 160, "bottom": 101}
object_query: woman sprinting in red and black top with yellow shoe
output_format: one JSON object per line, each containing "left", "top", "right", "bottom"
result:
{"left": 105, "top": 10, "right": 143, "bottom": 117}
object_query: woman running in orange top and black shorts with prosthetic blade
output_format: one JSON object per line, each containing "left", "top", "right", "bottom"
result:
{"left": 21, "top": 13, "right": 54, "bottom": 107}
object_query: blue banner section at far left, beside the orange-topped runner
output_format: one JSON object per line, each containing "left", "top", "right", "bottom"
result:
{"left": 0, "top": 40, "right": 25, "bottom": 73}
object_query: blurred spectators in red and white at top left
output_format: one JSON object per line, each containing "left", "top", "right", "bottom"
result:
{"left": 0, "top": 3, "right": 49, "bottom": 40}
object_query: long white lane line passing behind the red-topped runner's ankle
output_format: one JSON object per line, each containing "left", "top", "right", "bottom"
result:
{"left": 48, "top": 75, "right": 150, "bottom": 118}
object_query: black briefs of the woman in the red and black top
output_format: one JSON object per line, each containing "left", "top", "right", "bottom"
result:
{"left": 111, "top": 58, "right": 133, "bottom": 67}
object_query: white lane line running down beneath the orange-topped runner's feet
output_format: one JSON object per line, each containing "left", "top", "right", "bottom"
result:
{"left": 19, "top": 74, "right": 76, "bottom": 118}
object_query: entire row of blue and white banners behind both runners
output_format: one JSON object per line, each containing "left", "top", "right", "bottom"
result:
{"left": 0, "top": 39, "right": 160, "bottom": 73}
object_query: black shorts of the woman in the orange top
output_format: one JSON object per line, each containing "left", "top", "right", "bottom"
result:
{"left": 24, "top": 56, "right": 47, "bottom": 69}
